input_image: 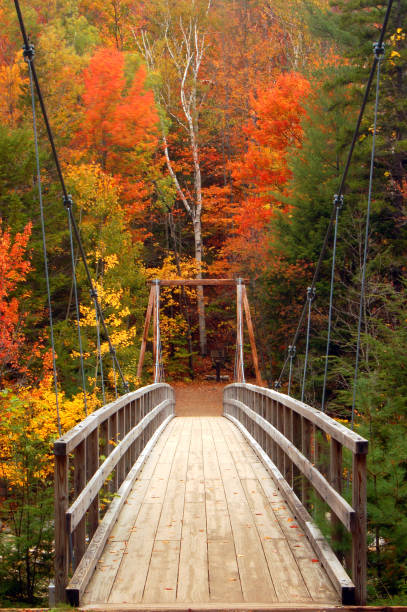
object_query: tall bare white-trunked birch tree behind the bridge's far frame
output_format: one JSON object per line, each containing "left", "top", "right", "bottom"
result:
{"left": 138, "top": 0, "right": 212, "bottom": 355}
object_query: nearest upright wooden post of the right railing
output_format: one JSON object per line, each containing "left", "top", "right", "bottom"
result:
{"left": 352, "top": 453, "right": 367, "bottom": 606}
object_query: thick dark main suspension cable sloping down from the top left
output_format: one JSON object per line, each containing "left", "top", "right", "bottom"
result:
{"left": 14, "top": 0, "right": 128, "bottom": 391}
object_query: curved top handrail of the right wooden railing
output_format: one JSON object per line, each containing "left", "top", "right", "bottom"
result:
{"left": 225, "top": 383, "right": 369, "bottom": 454}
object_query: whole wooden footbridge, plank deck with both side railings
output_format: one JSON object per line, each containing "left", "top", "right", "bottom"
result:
{"left": 54, "top": 383, "right": 368, "bottom": 610}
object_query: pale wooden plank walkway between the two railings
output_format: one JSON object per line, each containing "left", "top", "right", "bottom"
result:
{"left": 81, "top": 417, "right": 340, "bottom": 609}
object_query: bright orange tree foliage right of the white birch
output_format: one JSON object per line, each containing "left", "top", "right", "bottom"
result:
{"left": 215, "top": 73, "right": 310, "bottom": 276}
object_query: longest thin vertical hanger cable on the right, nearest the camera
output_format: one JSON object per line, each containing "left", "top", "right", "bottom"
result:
{"left": 351, "top": 43, "right": 384, "bottom": 430}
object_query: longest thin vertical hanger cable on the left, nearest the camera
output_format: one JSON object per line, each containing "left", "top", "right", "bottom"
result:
{"left": 24, "top": 50, "right": 62, "bottom": 436}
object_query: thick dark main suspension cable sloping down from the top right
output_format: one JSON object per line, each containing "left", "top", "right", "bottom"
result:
{"left": 275, "top": 0, "right": 393, "bottom": 389}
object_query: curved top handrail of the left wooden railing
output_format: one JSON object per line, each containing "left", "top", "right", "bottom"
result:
{"left": 54, "top": 383, "right": 175, "bottom": 455}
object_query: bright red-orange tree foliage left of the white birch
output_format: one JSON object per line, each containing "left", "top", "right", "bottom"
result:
{"left": 75, "top": 48, "right": 158, "bottom": 220}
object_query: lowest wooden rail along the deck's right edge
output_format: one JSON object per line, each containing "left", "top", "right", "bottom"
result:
{"left": 227, "top": 416, "right": 355, "bottom": 605}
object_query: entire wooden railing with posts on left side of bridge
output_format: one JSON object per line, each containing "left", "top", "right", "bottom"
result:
{"left": 54, "top": 383, "right": 175, "bottom": 605}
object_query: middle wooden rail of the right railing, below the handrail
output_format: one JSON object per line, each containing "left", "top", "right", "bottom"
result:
{"left": 228, "top": 400, "right": 355, "bottom": 531}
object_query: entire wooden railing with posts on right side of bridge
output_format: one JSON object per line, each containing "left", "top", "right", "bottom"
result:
{"left": 223, "top": 383, "right": 368, "bottom": 605}
